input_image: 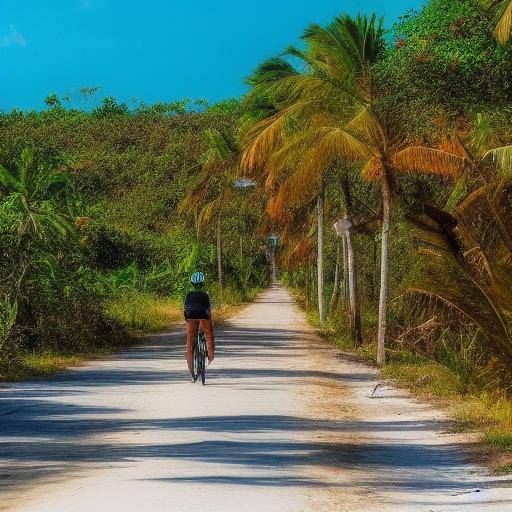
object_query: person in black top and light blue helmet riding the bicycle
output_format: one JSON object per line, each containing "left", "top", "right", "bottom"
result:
{"left": 184, "top": 272, "right": 215, "bottom": 379}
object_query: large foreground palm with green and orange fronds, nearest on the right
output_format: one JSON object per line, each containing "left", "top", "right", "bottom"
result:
{"left": 243, "top": 15, "right": 464, "bottom": 364}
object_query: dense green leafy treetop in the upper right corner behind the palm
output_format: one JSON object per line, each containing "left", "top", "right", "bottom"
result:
{"left": 376, "top": 0, "right": 512, "bottom": 136}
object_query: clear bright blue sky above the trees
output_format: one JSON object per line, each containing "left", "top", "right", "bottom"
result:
{"left": 0, "top": 0, "right": 420, "bottom": 110}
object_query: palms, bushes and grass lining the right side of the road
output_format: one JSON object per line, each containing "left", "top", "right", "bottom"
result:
{"left": 241, "top": 0, "right": 512, "bottom": 472}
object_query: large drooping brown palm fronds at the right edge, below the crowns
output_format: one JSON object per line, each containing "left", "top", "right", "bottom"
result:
{"left": 411, "top": 178, "right": 512, "bottom": 376}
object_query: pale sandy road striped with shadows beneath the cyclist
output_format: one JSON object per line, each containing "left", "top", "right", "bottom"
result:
{"left": 0, "top": 287, "right": 512, "bottom": 512}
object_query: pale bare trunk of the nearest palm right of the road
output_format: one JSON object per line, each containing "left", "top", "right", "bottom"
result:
{"left": 377, "top": 169, "right": 391, "bottom": 366}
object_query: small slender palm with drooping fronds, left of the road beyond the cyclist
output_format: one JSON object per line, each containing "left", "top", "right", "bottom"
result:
{"left": 180, "top": 129, "right": 239, "bottom": 296}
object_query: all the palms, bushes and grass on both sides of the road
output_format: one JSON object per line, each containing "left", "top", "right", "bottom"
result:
{"left": 0, "top": 0, "right": 512, "bottom": 468}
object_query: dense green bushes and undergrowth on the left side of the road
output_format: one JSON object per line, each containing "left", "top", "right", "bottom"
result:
{"left": 0, "top": 99, "right": 267, "bottom": 379}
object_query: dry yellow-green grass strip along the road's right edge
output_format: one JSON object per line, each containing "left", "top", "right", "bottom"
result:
{"left": 297, "top": 295, "right": 512, "bottom": 475}
